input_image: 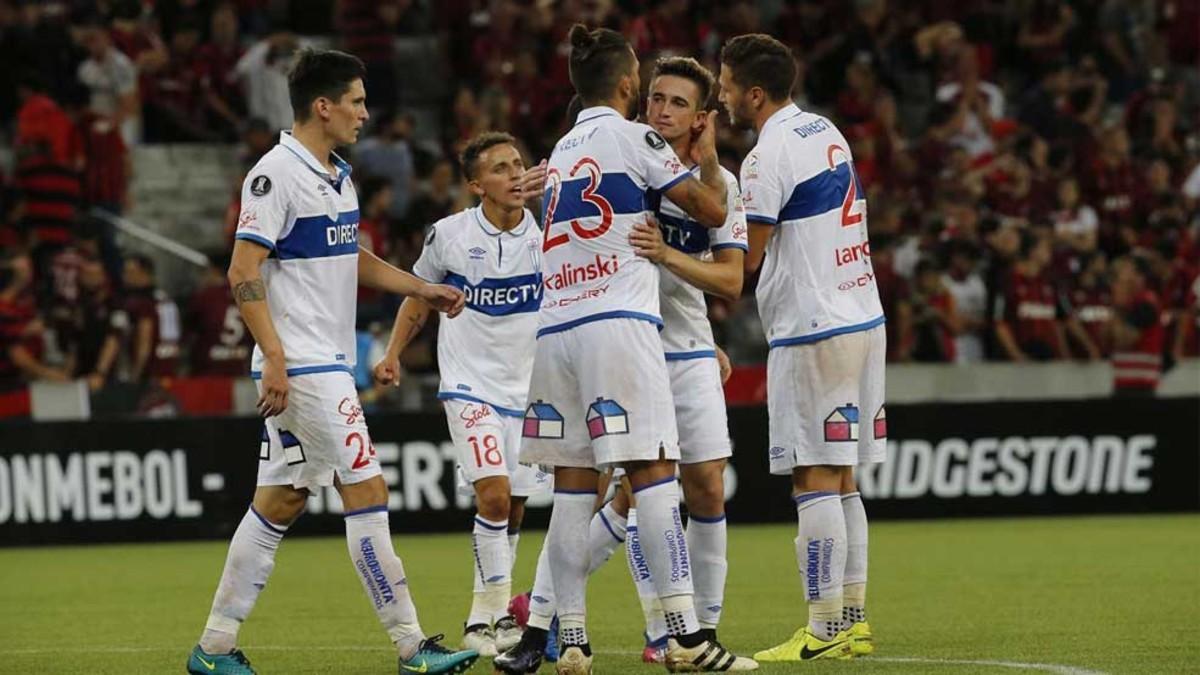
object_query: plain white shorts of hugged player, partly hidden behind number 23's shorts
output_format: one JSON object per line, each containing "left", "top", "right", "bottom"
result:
{"left": 667, "top": 358, "right": 733, "bottom": 464}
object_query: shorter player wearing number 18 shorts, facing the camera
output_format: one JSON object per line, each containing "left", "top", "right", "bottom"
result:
{"left": 374, "top": 132, "right": 551, "bottom": 656}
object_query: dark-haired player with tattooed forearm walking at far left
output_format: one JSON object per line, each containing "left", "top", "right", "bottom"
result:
{"left": 187, "top": 50, "right": 479, "bottom": 675}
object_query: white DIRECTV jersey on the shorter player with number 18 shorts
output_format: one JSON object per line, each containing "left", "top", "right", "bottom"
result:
{"left": 413, "top": 207, "right": 542, "bottom": 417}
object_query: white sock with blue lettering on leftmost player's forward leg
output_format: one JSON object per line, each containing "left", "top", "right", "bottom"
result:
{"left": 346, "top": 506, "right": 425, "bottom": 658}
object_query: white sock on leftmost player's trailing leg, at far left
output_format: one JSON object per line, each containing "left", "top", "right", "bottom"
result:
{"left": 200, "top": 506, "right": 288, "bottom": 653}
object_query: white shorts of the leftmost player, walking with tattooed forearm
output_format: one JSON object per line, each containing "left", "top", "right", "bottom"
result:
{"left": 257, "top": 371, "right": 379, "bottom": 489}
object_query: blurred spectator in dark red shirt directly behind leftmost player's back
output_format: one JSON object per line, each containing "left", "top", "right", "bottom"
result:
{"left": 184, "top": 256, "right": 254, "bottom": 377}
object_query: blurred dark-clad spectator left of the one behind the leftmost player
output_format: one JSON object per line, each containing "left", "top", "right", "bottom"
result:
{"left": 97, "top": 256, "right": 181, "bottom": 383}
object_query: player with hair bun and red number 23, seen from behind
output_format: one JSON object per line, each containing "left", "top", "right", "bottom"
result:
{"left": 494, "top": 25, "right": 733, "bottom": 674}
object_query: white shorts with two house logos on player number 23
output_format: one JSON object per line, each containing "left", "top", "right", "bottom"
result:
{"left": 521, "top": 318, "right": 679, "bottom": 470}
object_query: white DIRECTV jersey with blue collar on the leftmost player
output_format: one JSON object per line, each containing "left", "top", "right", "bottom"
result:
{"left": 235, "top": 132, "right": 359, "bottom": 377}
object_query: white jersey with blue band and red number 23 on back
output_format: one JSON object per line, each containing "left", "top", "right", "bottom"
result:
{"left": 538, "top": 107, "right": 691, "bottom": 336}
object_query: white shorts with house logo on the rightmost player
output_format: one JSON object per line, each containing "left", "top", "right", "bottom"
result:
{"left": 767, "top": 325, "right": 888, "bottom": 474}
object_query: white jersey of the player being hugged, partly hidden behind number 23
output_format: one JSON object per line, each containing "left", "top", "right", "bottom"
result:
{"left": 652, "top": 167, "right": 749, "bottom": 360}
